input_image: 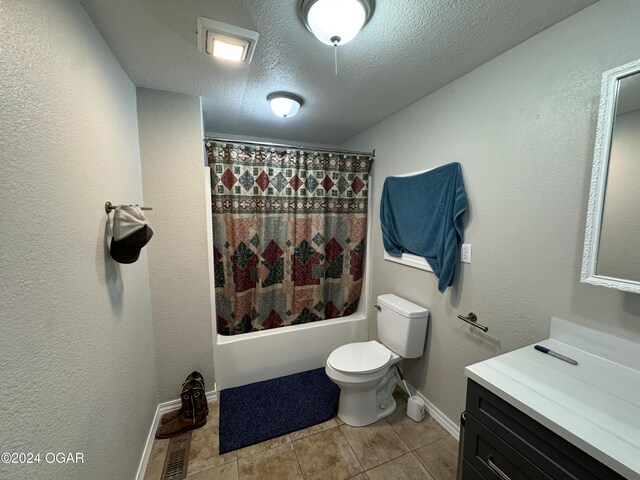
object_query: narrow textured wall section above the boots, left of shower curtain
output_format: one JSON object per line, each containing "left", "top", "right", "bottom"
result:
{"left": 138, "top": 89, "right": 213, "bottom": 402}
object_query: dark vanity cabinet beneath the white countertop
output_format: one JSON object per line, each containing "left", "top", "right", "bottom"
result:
{"left": 458, "top": 380, "right": 624, "bottom": 480}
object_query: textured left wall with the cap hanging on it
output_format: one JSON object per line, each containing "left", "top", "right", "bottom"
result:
{"left": 0, "top": 0, "right": 157, "bottom": 479}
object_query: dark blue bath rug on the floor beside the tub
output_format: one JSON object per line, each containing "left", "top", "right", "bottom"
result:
{"left": 219, "top": 368, "right": 340, "bottom": 454}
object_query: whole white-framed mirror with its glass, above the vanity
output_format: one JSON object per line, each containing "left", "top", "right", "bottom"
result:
{"left": 580, "top": 60, "right": 640, "bottom": 293}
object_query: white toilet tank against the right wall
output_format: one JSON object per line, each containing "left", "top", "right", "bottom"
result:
{"left": 378, "top": 294, "right": 429, "bottom": 358}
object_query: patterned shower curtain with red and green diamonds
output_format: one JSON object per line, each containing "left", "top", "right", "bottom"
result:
{"left": 205, "top": 141, "right": 373, "bottom": 335}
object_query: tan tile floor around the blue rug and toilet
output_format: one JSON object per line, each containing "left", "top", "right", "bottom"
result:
{"left": 144, "top": 390, "right": 458, "bottom": 480}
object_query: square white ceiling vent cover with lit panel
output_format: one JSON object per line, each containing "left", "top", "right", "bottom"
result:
{"left": 197, "top": 17, "right": 259, "bottom": 63}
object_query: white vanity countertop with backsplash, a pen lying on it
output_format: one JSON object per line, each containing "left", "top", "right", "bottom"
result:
{"left": 465, "top": 318, "right": 640, "bottom": 480}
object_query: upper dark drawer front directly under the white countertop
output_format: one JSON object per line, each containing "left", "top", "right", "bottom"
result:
{"left": 467, "top": 380, "right": 624, "bottom": 480}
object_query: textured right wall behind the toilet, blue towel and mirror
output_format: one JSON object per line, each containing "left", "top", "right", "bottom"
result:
{"left": 346, "top": 0, "right": 640, "bottom": 421}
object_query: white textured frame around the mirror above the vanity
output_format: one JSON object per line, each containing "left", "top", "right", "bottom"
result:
{"left": 580, "top": 60, "right": 640, "bottom": 293}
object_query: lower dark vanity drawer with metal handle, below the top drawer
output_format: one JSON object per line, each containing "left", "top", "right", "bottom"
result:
{"left": 463, "top": 413, "right": 551, "bottom": 480}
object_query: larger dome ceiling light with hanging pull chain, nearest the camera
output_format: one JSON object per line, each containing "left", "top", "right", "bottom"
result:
{"left": 300, "top": 0, "right": 375, "bottom": 75}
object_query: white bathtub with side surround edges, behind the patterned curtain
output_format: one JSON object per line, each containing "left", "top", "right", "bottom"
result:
{"left": 204, "top": 167, "right": 373, "bottom": 391}
